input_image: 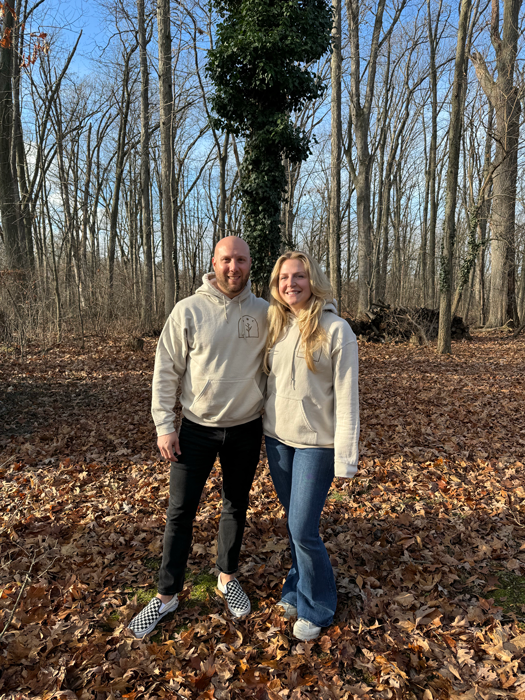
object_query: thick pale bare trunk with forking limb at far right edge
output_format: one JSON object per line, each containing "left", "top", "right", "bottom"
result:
{"left": 471, "top": 0, "right": 522, "bottom": 327}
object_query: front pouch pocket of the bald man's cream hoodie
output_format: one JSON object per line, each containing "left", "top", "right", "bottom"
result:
{"left": 189, "top": 379, "right": 264, "bottom": 423}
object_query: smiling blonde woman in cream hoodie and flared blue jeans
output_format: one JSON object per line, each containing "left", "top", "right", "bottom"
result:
{"left": 263, "top": 251, "right": 359, "bottom": 641}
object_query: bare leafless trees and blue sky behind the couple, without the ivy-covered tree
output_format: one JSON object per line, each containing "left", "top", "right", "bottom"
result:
{"left": 0, "top": 0, "right": 525, "bottom": 351}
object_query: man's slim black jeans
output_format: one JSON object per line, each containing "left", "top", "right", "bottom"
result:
{"left": 158, "top": 418, "right": 262, "bottom": 595}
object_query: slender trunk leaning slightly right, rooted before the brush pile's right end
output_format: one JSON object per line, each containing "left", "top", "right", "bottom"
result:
{"left": 437, "top": 0, "right": 472, "bottom": 355}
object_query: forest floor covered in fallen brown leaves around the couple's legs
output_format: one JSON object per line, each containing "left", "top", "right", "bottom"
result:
{"left": 0, "top": 334, "right": 525, "bottom": 700}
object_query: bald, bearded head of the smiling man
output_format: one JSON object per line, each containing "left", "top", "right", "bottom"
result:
{"left": 212, "top": 236, "right": 252, "bottom": 299}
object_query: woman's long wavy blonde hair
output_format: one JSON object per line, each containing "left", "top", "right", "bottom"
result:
{"left": 264, "top": 250, "right": 334, "bottom": 373}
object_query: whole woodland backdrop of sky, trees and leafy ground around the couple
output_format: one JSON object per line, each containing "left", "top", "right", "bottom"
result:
{"left": 0, "top": 0, "right": 525, "bottom": 700}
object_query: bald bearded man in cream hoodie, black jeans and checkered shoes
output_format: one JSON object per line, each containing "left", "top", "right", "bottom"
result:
{"left": 129, "top": 236, "right": 268, "bottom": 638}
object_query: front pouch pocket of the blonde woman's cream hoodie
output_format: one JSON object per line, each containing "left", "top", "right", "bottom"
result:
{"left": 264, "top": 394, "right": 317, "bottom": 445}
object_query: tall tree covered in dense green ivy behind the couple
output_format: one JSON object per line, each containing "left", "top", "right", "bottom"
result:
{"left": 207, "top": 0, "right": 332, "bottom": 289}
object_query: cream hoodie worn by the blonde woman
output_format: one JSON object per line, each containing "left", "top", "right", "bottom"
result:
{"left": 263, "top": 304, "right": 359, "bottom": 478}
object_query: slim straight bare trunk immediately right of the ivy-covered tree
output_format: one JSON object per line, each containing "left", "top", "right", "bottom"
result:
{"left": 328, "top": 0, "right": 342, "bottom": 309}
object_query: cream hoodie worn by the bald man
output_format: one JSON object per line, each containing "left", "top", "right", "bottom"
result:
{"left": 151, "top": 273, "right": 268, "bottom": 435}
